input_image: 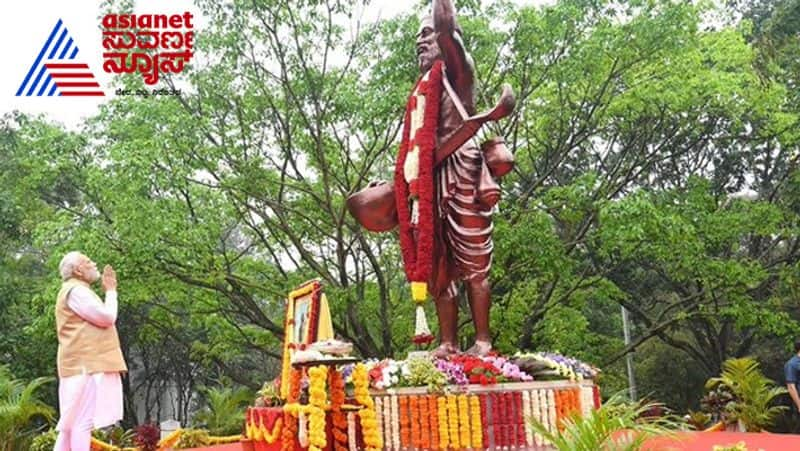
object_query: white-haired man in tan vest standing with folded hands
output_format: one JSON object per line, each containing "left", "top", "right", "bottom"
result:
{"left": 55, "top": 252, "right": 128, "bottom": 451}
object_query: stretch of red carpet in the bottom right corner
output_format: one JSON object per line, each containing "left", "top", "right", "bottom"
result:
{"left": 644, "top": 432, "right": 800, "bottom": 451}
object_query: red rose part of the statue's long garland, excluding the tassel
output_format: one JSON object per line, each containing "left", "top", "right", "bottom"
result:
{"left": 394, "top": 60, "right": 443, "bottom": 290}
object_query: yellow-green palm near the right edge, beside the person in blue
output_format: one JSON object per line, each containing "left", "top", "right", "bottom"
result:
{"left": 706, "top": 357, "right": 787, "bottom": 432}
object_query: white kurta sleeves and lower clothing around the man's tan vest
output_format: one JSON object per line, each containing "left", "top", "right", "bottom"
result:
{"left": 55, "top": 286, "right": 122, "bottom": 451}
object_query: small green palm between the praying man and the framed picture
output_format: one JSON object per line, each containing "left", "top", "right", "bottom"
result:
{"left": 194, "top": 387, "right": 253, "bottom": 436}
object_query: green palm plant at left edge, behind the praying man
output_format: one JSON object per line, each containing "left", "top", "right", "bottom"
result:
{"left": 0, "top": 365, "right": 54, "bottom": 451}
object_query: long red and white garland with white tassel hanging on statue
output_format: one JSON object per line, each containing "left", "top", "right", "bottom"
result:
{"left": 394, "top": 60, "right": 444, "bottom": 344}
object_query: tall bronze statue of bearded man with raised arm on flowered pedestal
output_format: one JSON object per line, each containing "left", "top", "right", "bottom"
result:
{"left": 348, "top": 0, "right": 514, "bottom": 357}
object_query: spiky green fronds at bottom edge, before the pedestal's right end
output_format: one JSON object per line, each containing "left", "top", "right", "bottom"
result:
{"left": 528, "top": 395, "right": 681, "bottom": 451}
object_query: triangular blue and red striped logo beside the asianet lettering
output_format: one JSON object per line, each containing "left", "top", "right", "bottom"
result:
{"left": 17, "top": 19, "right": 105, "bottom": 97}
